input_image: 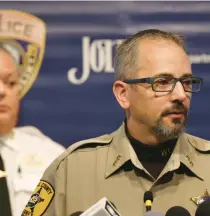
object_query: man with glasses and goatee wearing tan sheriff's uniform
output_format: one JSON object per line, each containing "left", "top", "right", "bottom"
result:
{"left": 22, "top": 29, "right": 210, "bottom": 216}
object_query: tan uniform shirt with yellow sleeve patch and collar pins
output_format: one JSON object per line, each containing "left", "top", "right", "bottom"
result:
{"left": 22, "top": 125, "right": 210, "bottom": 216}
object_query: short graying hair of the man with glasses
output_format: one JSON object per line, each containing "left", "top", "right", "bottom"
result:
{"left": 114, "top": 29, "right": 187, "bottom": 80}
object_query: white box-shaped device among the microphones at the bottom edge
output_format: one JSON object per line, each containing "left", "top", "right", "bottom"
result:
{"left": 77, "top": 197, "right": 121, "bottom": 216}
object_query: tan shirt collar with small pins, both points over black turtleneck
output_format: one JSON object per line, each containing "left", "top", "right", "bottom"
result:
{"left": 105, "top": 123, "right": 203, "bottom": 180}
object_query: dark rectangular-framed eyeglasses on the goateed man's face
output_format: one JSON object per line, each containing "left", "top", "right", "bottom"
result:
{"left": 123, "top": 76, "right": 203, "bottom": 93}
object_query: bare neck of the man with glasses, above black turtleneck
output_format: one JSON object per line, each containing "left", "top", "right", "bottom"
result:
{"left": 126, "top": 118, "right": 168, "bottom": 145}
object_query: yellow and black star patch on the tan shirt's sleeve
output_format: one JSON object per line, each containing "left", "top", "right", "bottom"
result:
{"left": 21, "top": 180, "right": 55, "bottom": 216}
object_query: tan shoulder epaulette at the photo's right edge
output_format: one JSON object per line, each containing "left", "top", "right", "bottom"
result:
{"left": 188, "top": 134, "right": 210, "bottom": 153}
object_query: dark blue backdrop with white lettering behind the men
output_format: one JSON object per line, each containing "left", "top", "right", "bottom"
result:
{"left": 0, "top": 1, "right": 210, "bottom": 147}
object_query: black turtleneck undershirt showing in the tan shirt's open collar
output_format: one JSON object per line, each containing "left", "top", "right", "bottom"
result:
{"left": 125, "top": 123, "right": 177, "bottom": 179}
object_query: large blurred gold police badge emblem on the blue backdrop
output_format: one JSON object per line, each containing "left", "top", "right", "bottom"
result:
{"left": 0, "top": 10, "right": 46, "bottom": 99}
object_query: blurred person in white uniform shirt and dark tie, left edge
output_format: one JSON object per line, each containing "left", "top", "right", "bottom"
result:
{"left": 0, "top": 43, "right": 65, "bottom": 216}
